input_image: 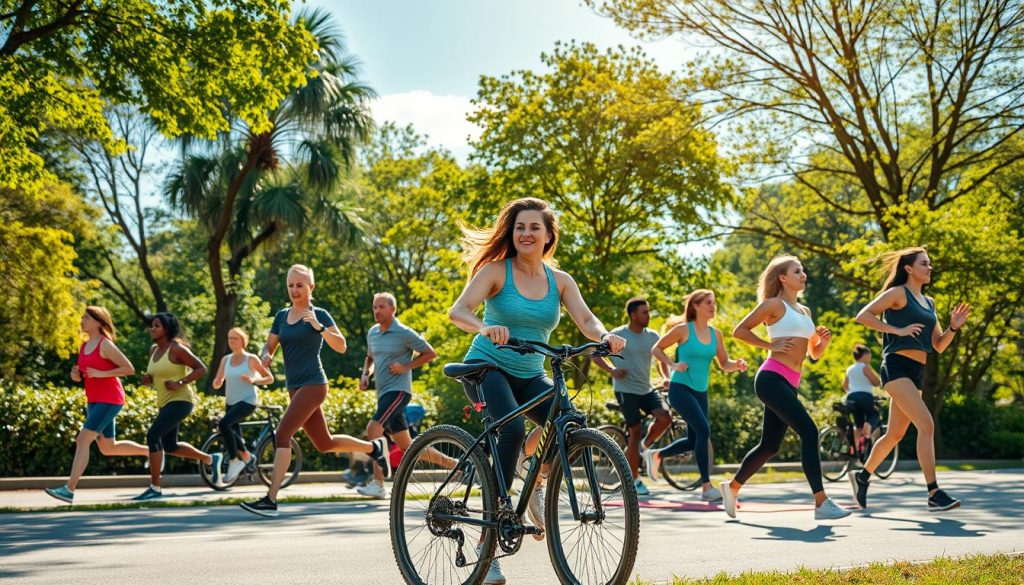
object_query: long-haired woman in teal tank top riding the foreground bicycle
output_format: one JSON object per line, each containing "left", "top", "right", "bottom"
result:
{"left": 449, "top": 198, "right": 626, "bottom": 584}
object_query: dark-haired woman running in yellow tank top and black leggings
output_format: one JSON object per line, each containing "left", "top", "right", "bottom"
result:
{"left": 133, "top": 312, "right": 222, "bottom": 500}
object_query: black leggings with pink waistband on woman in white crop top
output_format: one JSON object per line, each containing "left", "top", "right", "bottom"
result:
{"left": 735, "top": 370, "right": 824, "bottom": 494}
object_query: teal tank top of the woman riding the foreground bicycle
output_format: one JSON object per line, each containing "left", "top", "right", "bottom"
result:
{"left": 466, "top": 258, "right": 561, "bottom": 378}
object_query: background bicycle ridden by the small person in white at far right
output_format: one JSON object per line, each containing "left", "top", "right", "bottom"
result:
{"left": 818, "top": 396, "right": 899, "bottom": 482}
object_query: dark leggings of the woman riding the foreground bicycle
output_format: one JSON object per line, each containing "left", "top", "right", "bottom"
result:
{"left": 465, "top": 360, "right": 555, "bottom": 490}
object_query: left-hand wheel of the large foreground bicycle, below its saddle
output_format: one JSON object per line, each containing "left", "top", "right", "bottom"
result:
{"left": 390, "top": 424, "right": 498, "bottom": 585}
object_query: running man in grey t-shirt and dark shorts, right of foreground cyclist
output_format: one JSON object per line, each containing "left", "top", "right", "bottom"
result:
{"left": 593, "top": 297, "right": 672, "bottom": 496}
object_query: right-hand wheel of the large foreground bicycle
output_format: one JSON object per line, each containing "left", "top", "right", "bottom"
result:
{"left": 544, "top": 428, "right": 640, "bottom": 585}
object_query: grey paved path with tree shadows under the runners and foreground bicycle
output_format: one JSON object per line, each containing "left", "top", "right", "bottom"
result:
{"left": 0, "top": 470, "right": 1024, "bottom": 585}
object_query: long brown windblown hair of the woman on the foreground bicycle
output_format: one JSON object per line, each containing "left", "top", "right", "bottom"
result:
{"left": 461, "top": 197, "right": 558, "bottom": 279}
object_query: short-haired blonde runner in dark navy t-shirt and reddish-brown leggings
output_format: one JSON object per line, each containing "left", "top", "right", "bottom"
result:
{"left": 239, "top": 264, "right": 391, "bottom": 517}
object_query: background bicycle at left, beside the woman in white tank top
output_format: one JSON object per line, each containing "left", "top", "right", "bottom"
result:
{"left": 199, "top": 405, "right": 302, "bottom": 492}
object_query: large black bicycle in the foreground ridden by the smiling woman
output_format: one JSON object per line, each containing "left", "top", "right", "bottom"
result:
{"left": 390, "top": 339, "right": 640, "bottom": 585}
